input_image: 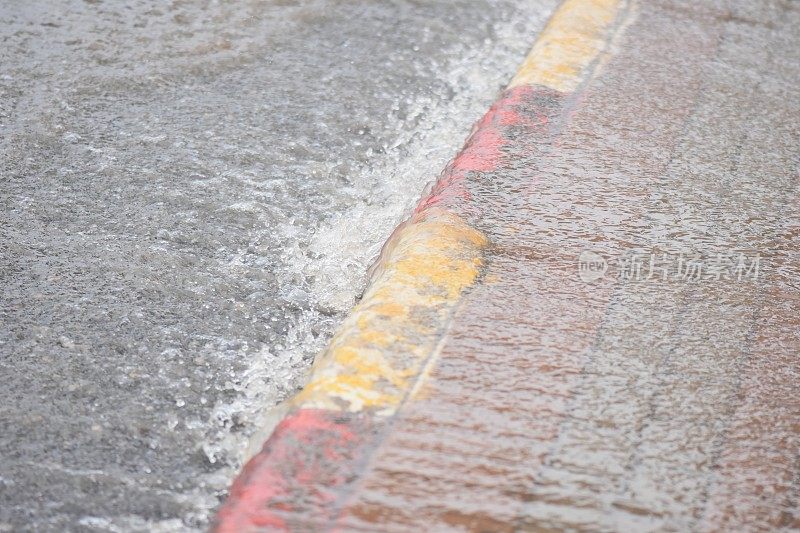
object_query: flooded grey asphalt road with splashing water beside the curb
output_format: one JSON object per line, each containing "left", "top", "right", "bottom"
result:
{"left": 0, "top": 0, "right": 555, "bottom": 531}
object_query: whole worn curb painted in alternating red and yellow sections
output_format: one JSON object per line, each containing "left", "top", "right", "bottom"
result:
{"left": 213, "top": 0, "right": 630, "bottom": 533}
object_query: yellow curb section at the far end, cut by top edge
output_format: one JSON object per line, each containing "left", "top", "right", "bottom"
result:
{"left": 508, "top": 0, "right": 622, "bottom": 93}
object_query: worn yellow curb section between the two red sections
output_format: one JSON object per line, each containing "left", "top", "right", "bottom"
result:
{"left": 294, "top": 210, "right": 487, "bottom": 414}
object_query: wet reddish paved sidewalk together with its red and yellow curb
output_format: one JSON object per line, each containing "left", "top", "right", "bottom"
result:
{"left": 217, "top": 0, "right": 800, "bottom": 531}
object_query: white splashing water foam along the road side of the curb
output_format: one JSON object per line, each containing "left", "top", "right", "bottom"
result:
{"left": 192, "top": 0, "right": 556, "bottom": 524}
